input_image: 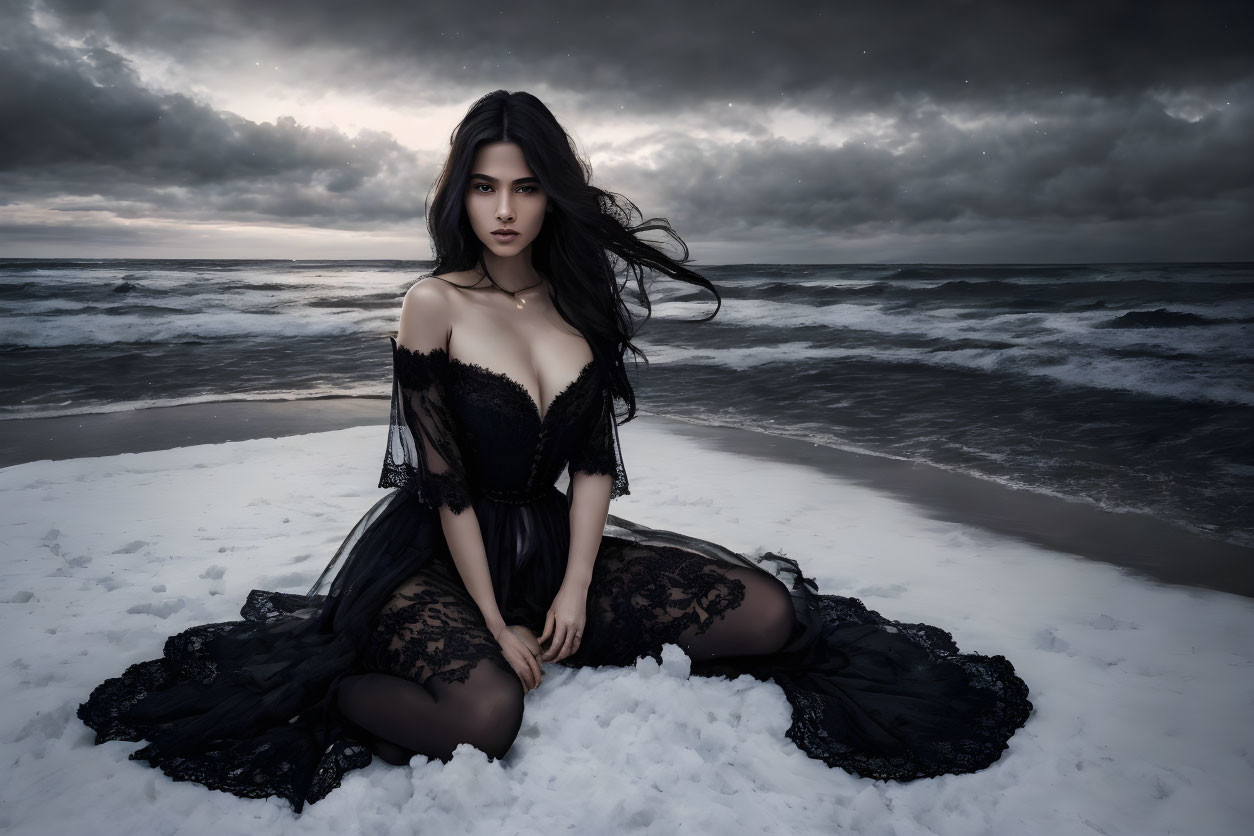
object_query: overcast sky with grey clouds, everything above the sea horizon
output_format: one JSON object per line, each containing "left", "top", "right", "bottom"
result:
{"left": 0, "top": 0, "right": 1254, "bottom": 264}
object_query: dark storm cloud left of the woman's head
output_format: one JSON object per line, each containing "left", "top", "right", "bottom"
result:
{"left": 0, "top": 3, "right": 425, "bottom": 226}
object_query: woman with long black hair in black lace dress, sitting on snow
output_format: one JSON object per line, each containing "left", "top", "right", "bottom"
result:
{"left": 79, "top": 90, "right": 1032, "bottom": 812}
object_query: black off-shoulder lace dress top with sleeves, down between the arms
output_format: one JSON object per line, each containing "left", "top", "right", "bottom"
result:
{"left": 379, "top": 337, "right": 630, "bottom": 614}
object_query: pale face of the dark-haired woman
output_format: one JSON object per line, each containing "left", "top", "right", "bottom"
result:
{"left": 465, "top": 142, "right": 548, "bottom": 257}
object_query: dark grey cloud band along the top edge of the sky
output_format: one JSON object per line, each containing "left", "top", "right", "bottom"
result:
{"left": 24, "top": 0, "right": 1254, "bottom": 109}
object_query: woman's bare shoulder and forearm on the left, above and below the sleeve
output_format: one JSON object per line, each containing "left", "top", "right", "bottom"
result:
{"left": 396, "top": 280, "right": 505, "bottom": 637}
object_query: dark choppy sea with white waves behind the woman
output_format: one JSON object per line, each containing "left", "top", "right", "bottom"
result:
{"left": 0, "top": 259, "right": 1254, "bottom": 545}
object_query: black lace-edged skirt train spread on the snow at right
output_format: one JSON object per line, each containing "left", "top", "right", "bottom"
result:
{"left": 668, "top": 548, "right": 1033, "bottom": 781}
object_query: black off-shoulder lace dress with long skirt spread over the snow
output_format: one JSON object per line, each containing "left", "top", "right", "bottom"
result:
{"left": 78, "top": 340, "right": 1032, "bottom": 812}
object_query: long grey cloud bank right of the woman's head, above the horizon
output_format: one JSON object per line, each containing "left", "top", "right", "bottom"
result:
{"left": 614, "top": 93, "right": 1254, "bottom": 236}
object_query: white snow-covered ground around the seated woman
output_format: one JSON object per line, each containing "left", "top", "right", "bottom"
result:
{"left": 0, "top": 422, "right": 1254, "bottom": 836}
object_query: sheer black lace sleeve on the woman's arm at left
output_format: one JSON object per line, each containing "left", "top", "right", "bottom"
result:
{"left": 379, "top": 337, "right": 470, "bottom": 514}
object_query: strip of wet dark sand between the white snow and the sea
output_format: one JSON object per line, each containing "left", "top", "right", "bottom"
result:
{"left": 0, "top": 397, "right": 1254, "bottom": 598}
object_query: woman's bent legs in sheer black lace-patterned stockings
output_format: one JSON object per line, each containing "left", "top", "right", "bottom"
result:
{"left": 339, "top": 560, "right": 794, "bottom": 765}
